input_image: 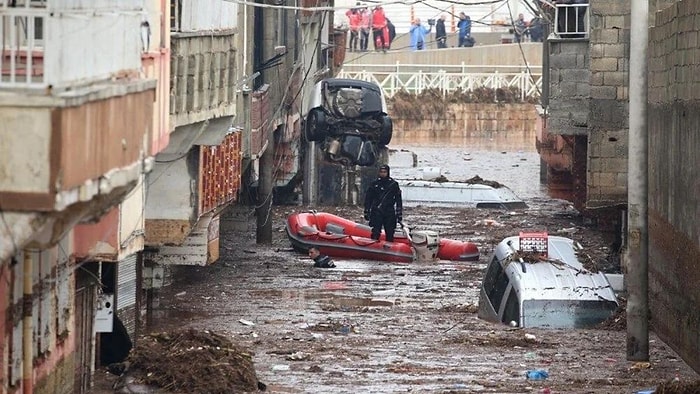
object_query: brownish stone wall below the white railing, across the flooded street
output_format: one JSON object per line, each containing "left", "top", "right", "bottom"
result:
{"left": 389, "top": 104, "right": 538, "bottom": 138}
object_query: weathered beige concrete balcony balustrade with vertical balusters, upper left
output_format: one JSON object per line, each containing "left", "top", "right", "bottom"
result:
{"left": 170, "top": 30, "right": 237, "bottom": 129}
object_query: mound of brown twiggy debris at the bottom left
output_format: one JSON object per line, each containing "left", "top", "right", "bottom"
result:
{"left": 123, "top": 329, "right": 265, "bottom": 394}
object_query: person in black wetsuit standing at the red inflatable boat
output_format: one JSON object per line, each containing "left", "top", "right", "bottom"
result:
{"left": 364, "top": 164, "right": 403, "bottom": 242}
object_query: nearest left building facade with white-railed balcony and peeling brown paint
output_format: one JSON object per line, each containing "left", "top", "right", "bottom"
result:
{"left": 0, "top": 0, "right": 160, "bottom": 393}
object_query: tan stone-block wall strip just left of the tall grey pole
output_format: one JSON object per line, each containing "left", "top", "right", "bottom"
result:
{"left": 587, "top": 0, "right": 630, "bottom": 208}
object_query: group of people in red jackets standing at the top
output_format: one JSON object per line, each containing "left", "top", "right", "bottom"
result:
{"left": 345, "top": 3, "right": 396, "bottom": 52}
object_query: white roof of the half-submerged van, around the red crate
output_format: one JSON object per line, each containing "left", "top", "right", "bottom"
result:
{"left": 495, "top": 236, "right": 616, "bottom": 301}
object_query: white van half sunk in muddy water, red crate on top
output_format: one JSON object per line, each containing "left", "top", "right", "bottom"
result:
{"left": 479, "top": 233, "right": 618, "bottom": 328}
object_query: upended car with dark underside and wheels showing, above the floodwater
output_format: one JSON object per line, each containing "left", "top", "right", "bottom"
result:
{"left": 304, "top": 78, "right": 393, "bottom": 166}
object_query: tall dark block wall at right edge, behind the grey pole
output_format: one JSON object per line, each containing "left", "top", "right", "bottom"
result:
{"left": 648, "top": 0, "right": 700, "bottom": 372}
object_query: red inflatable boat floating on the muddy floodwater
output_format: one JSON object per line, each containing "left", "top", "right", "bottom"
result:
{"left": 286, "top": 212, "right": 479, "bottom": 263}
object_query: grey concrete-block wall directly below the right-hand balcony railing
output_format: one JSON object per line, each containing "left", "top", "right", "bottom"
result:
{"left": 547, "top": 39, "right": 591, "bottom": 135}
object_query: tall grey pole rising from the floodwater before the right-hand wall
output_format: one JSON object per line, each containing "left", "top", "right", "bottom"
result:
{"left": 625, "top": 0, "right": 649, "bottom": 361}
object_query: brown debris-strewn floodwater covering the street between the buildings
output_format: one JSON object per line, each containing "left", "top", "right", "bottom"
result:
{"left": 90, "top": 136, "right": 699, "bottom": 393}
